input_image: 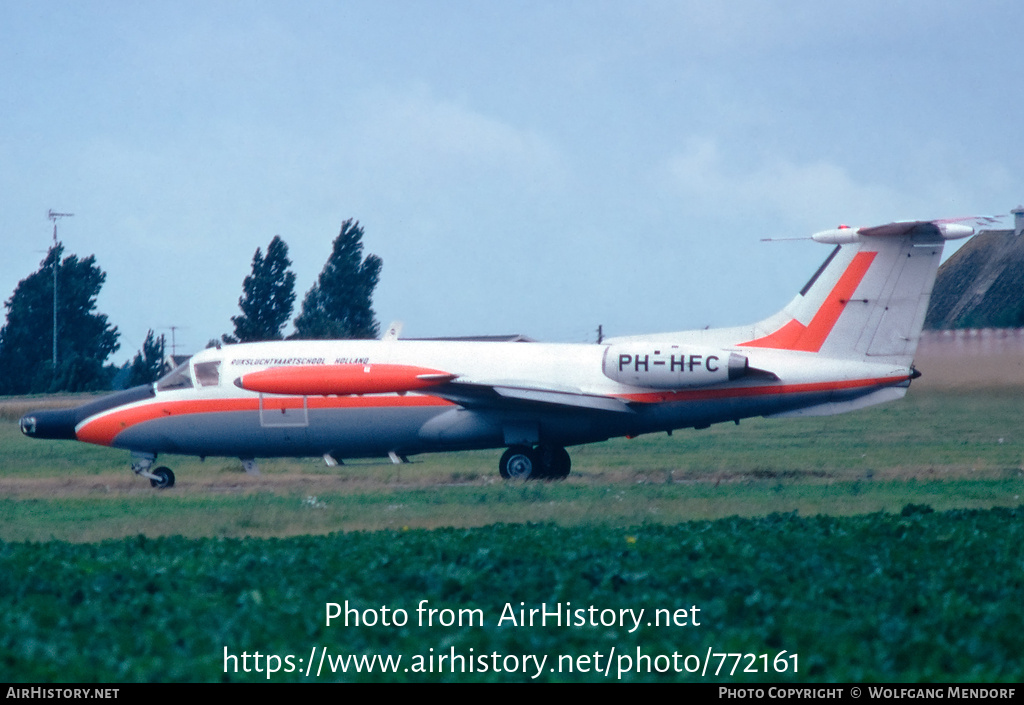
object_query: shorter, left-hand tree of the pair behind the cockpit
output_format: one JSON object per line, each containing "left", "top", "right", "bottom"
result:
{"left": 221, "top": 235, "right": 295, "bottom": 343}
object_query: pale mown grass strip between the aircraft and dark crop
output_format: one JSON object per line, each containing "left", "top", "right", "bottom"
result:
{"left": 0, "top": 388, "right": 1024, "bottom": 541}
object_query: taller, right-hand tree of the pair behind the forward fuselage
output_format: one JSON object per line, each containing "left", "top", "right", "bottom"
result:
{"left": 292, "top": 219, "right": 383, "bottom": 340}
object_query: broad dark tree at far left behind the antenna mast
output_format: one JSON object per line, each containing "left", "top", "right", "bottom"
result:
{"left": 0, "top": 243, "right": 121, "bottom": 395}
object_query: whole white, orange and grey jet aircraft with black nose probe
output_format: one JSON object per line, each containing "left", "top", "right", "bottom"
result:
{"left": 20, "top": 218, "right": 985, "bottom": 488}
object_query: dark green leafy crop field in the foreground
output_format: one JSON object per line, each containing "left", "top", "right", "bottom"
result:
{"left": 0, "top": 506, "right": 1024, "bottom": 682}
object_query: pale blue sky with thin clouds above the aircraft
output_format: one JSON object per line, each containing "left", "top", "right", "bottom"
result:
{"left": 0, "top": 0, "right": 1024, "bottom": 364}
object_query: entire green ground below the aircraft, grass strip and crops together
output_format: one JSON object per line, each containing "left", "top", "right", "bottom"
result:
{"left": 0, "top": 388, "right": 1024, "bottom": 682}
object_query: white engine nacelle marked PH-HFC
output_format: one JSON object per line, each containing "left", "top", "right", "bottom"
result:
{"left": 602, "top": 343, "right": 750, "bottom": 389}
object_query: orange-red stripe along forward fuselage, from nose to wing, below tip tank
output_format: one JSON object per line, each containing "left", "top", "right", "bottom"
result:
{"left": 76, "top": 395, "right": 454, "bottom": 446}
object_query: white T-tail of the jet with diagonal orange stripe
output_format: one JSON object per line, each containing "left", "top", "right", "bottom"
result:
{"left": 740, "top": 220, "right": 974, "bottom": 367}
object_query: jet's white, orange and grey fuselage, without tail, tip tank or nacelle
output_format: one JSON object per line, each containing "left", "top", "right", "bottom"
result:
{"left": 66, "top": 334, "right": 908, "bottom": 459}
